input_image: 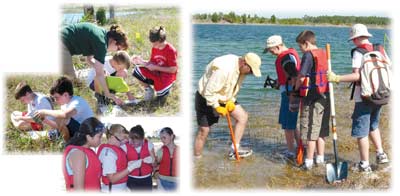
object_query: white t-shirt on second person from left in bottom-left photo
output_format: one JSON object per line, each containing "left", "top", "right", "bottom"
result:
{"left": 99, "top": 145, "right": 127, "bottom": 192}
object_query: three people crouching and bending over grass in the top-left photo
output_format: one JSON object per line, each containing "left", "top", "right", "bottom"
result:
{"left": 61, "top": 23, "right": 178, "bottom": 105}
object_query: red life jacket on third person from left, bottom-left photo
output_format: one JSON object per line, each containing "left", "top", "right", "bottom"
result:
{"left": 126, "top": 139, "right": 153, "bottom": 176}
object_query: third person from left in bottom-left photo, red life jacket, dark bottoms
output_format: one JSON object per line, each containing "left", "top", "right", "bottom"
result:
{"left": 127, "top": 125, "right": 155, "bottom": 190}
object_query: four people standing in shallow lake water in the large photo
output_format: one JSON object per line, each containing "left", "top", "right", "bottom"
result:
{"left": 194, "top": 24, "right": 390, "bottom": 172}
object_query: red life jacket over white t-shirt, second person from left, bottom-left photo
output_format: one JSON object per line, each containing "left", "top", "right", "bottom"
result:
{"left": 97, "top": 144, "right": 128, "bottom": 185}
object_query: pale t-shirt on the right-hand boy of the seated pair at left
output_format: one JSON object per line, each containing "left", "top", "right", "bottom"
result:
{"left": 61, "top": 96, "right": 94, "bottom": 123}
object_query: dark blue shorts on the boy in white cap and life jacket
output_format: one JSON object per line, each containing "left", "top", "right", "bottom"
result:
{"left": 279, "top": 92, "right": 299, "bottom": 130}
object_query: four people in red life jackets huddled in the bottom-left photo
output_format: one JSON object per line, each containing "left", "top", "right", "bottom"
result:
{"left": 63, "top": 117, "right": 179, "bottom": 192}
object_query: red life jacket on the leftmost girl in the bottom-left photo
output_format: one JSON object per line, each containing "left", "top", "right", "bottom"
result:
{"left": 63, "top": 145, "right": 101, "bottom": 191}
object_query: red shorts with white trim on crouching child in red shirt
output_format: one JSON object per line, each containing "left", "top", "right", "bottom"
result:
{"left": 132, "top": 66, "right": 176, "bottom": 97}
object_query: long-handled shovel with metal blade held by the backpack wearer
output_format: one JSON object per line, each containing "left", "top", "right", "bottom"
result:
{"left": 326, "top": 44, "right": 347, "bottom": 183}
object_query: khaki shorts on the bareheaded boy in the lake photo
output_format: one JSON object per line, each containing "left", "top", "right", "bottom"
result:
{"left": 300, "top": 97, "right": 330, "bottom": 141}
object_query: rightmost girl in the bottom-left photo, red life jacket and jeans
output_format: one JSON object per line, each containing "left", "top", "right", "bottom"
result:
{"left": 156, "top": 127, "right": 179, "bottom": 191}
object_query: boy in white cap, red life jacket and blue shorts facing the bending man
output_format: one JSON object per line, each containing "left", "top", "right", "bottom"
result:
{"left": 264, "top": 35, "right": 300, "bottom": 159}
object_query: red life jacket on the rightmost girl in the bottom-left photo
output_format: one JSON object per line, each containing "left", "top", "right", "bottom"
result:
{"left": 159, "top": 146, "right": 178, "bottom": 176}
